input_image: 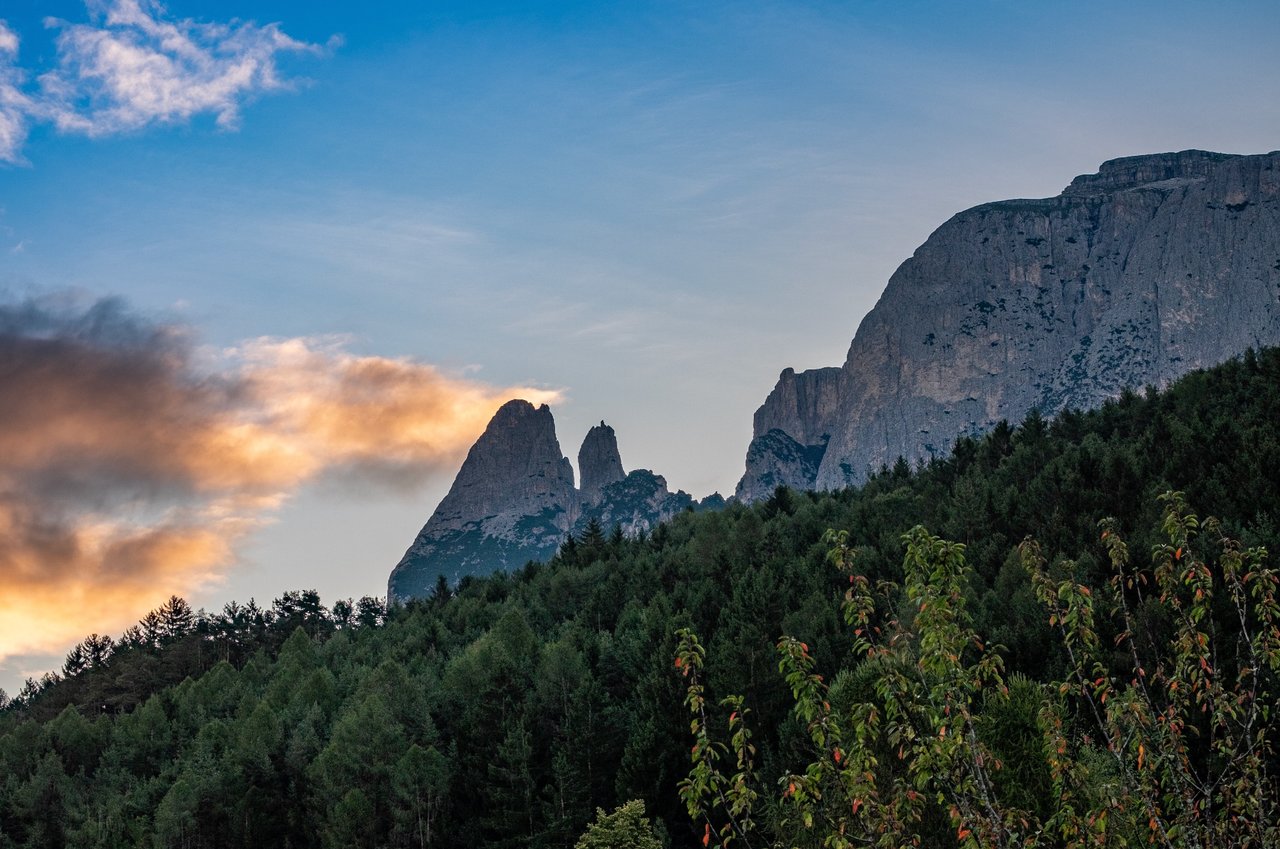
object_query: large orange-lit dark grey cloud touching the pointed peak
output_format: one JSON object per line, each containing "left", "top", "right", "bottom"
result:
{"left": 0, "top": 296, "right": 558, "bottom": 661}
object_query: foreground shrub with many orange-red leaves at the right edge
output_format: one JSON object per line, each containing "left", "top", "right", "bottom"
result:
{"left": 1021, "top": 492, "right": 1280, "bottom": 846}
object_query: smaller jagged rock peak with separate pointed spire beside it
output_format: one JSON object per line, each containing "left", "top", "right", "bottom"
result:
{"left": 387, "top": 401, "right": 723, "bottom": 601}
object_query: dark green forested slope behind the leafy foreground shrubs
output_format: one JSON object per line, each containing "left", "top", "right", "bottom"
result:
{"left": 0, "top": 350, "right": 1280, "bottom": 849}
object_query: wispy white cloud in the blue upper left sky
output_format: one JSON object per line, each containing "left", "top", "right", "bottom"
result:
{"left": 0, "top": 0, "right": 323, "bottom": 163}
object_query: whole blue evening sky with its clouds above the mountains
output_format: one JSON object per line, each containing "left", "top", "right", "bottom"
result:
{"left": 0, "top": 0, "right": 1280, "bottom": 694}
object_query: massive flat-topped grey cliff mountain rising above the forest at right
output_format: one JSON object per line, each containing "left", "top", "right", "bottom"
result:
{"left": 736, "top": 150, "right": 1280, "bottom": 501}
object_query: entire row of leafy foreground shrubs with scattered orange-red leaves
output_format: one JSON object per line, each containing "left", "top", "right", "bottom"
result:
{"left": 676, "top": 492, "right": 1280, "bottom": 849}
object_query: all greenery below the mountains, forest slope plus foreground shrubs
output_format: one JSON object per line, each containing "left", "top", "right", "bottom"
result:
{"left": 0, "top": 350, "right": 1280, "bottom": 849}
